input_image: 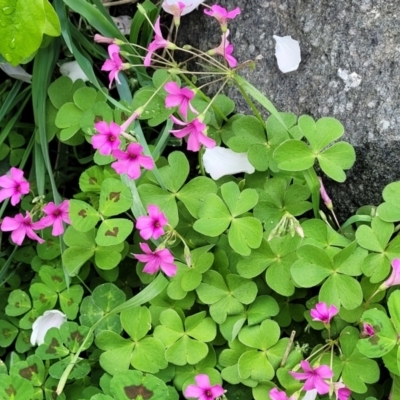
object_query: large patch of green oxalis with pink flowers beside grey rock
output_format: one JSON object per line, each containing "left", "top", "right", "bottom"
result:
{"left": 0, "top": 0, "right": 400, "bottom": 400}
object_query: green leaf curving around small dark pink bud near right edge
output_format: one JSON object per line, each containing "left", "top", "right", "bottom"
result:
{"left": 357, "top": 309, "right": 397, "bottom": 358}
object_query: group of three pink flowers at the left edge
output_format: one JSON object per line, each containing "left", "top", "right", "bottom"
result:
{"left": 0, "top": 167, "right": 71, "bottom": 246}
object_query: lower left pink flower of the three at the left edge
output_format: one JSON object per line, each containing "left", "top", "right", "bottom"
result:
{"left": 0, "top": 212, "right": 44, "bottom": 246}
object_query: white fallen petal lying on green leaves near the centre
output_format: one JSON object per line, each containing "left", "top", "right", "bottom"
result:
{"left": 203, "top": 146, "right": 255, "bottom": 180}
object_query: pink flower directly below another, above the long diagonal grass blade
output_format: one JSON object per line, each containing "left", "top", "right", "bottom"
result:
{"left": 134, "top": 243, "right": 176, "bottom": 277}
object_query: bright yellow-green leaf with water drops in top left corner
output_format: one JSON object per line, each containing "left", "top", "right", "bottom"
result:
{"left": 0, "top": 0, "right": 46, "bottom": 66}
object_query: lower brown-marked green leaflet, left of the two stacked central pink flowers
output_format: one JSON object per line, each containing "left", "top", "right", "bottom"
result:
{"left": 95, "top": 218, "right": 133, "bottom": 246}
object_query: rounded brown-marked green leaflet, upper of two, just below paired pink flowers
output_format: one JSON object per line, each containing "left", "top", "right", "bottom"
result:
{"left": 99, "top": 178, "right": 132, "bottom": 217}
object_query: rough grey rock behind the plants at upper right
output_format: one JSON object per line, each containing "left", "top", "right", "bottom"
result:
{"left": 181, "top": 0, "right": 400, "bottom": 218}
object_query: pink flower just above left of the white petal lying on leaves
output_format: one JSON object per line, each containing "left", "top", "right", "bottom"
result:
{"left": 170, "top": 116, "right": 215, "bottom": 151}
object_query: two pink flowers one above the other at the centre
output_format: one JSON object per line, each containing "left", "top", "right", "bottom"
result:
{"left": 134, "top": 204, "right": 176, "bottom": 277}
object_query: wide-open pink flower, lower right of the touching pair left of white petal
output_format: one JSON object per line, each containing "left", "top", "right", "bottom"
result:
{"left": 111, "top": 143, "right": 154, "bottom": 179}
